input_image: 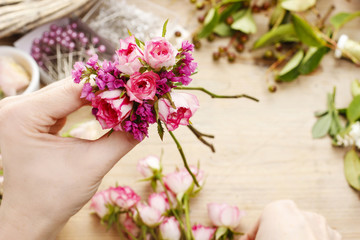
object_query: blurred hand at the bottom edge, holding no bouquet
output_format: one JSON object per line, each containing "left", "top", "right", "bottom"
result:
{"left": 240, "top": 200, "right": 342, "bottom": 240}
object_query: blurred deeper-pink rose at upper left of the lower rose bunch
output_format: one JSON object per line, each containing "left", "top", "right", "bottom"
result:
{"left": 109, "top": 186, "right": 140, "bottom": 210}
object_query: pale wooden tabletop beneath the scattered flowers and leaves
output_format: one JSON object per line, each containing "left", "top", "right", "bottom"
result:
{"left": 54, "top": 0, "right": 360, "bottom": 240}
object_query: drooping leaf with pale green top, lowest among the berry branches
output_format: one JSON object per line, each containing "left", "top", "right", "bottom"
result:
{"left": 277, "top": 49, "right": 304, "bottom": 82}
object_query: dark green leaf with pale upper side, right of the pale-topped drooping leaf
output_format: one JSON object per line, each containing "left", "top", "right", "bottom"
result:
{"left": 299, "top": 47, "right": 330, "bottom": 74}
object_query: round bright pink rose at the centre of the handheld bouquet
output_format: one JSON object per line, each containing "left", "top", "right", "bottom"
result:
{"left": 125, "top": 72, "right": 160, "bottom": 103}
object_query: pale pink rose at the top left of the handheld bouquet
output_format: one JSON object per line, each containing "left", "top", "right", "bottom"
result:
{"left": 116, "top": 36, "right": 144, "bottom": 75}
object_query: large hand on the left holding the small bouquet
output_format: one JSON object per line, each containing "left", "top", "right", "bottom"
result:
{"left": 0, "top": 79, "right": 138, "bottom": 240}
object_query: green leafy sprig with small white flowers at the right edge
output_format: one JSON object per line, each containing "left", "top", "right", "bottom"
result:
{"left": 312, "top": 80, "right": 360, "bottom": 191}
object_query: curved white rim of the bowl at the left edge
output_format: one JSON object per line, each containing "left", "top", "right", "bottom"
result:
{"left": 0, "top": 46, "right": 40, "bottom": 94}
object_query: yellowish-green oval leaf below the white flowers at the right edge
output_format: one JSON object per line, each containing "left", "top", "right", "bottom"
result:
{"left": 344, "top": 149, "right": 360, "bottom": 191}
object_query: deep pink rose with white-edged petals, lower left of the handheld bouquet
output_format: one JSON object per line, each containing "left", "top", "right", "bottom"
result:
{"left": 92, "top": 90, "right": 133, "bottom": 131}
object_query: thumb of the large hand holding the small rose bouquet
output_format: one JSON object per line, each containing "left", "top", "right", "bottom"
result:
{"left": 80, "top": 129, "right": 139, "bottom": 175}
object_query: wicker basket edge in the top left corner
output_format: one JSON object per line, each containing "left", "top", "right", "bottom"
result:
{"left": 0, "top": 0, "right": 97, "bottom": 38}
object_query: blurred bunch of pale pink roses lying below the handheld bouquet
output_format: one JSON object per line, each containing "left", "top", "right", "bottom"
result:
{"left": 90, "top": 156, "right": 245, "bottom": 240}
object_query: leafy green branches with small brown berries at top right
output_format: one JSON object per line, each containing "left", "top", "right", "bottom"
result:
{"left": 191, "top": 0, "right": 360, "bottom": 92}
